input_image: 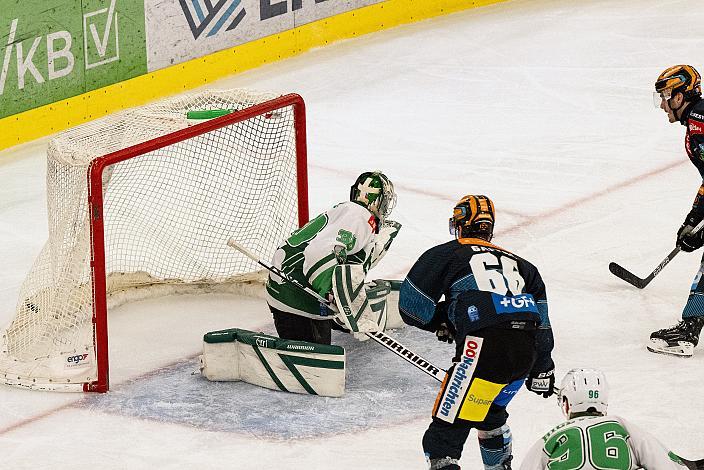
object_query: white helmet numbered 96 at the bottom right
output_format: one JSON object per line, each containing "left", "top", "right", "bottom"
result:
{"left": 557, "top": 369, "right": 609, "bottom": 419}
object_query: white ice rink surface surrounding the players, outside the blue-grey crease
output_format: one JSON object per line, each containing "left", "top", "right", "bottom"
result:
{"left": 0, "top": 0, "right": 704, "bottom": 470}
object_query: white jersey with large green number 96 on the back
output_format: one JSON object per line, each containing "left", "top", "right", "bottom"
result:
{"left": 521, "top": 416, "right": 687, "bottom": 470}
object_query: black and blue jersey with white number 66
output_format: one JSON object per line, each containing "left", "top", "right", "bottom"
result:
{"left": 399, "top": 238, "right": 554, "bottom": 370}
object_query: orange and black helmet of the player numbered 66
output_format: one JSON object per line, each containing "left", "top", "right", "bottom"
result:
{"left": 450, "top": 194, "right": 495, "bottom": 241}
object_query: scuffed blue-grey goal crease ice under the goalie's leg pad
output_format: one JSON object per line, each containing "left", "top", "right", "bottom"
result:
{"left": 85, "top": 328, "right": 453, "bottom": 439}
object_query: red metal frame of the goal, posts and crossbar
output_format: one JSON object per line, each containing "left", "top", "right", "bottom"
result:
{"left": 83, "top": 93, "right": 309, "bottom": 393}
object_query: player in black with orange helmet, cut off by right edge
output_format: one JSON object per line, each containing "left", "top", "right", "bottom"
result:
{"left": 648, "top": 65, "right": 704, "bottom": 357}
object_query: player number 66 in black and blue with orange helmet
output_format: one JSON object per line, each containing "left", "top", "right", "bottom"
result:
{"left": 399, "top": 195, "right": 555, "bottom": 470}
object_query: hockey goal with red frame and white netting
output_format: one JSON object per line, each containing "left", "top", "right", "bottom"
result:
{"left": 0, "top": 90, "right": 308, "bottom": 392}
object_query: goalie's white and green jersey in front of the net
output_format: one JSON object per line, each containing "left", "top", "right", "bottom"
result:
{"left": 266, "top": 202, "right": 400, "bottom": 318}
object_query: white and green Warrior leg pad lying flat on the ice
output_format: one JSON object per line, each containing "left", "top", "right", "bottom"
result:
{"left": 200, "top": 328, "right": 345, "bottom": 397}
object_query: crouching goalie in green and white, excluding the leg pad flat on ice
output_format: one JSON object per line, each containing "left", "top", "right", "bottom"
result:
{"left": 266, "top": 171, "right": 401, "bottom": 344}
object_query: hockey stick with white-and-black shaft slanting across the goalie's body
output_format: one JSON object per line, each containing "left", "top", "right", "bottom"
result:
{"left": 227, "top": 238, "right": 447, "bottom": 382}
